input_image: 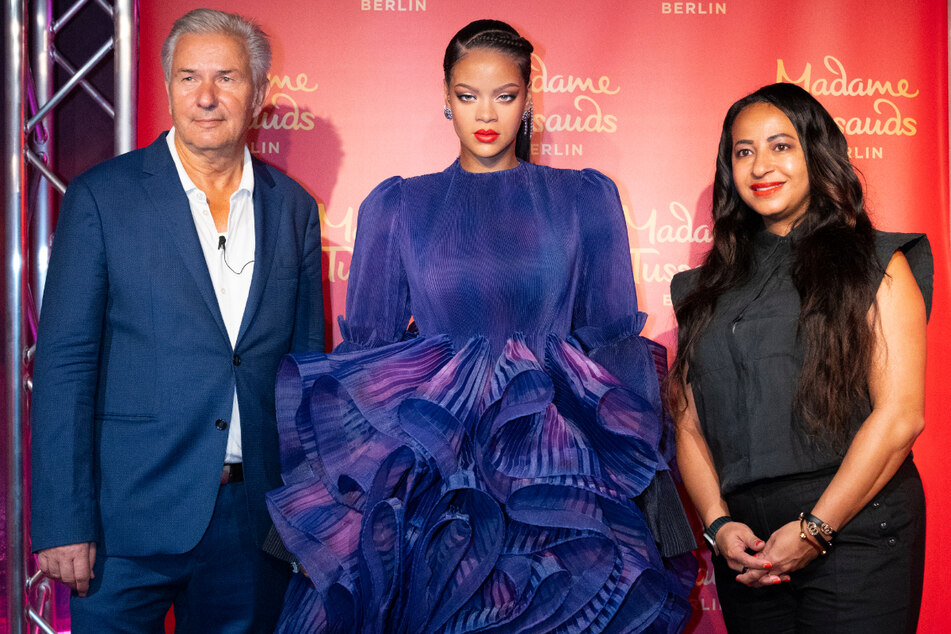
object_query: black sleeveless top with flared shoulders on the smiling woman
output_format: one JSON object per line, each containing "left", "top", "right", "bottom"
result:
{"left": 670, "top": 230, "right": 934, "bottom": 494}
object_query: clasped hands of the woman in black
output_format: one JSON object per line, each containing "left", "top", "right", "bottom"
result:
{"left": 717, "top": 521, "right": 818, "bottom": 588}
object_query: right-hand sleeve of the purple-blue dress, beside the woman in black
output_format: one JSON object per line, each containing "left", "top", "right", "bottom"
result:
{"left": 572, "top": 169, "right": 696, "bottom": 557}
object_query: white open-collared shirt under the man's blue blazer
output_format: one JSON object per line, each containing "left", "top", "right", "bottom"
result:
{"left": 165, "top": 127, "right": 254, "bottom": 463}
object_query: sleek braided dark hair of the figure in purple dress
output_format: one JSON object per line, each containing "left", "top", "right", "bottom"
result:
{"left": 442, "top": 20, "right": 535, "bottom": 161}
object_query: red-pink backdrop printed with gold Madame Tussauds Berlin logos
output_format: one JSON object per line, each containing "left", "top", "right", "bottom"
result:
{"left": 139, "top": 0, "right": 951, "bottom": 632}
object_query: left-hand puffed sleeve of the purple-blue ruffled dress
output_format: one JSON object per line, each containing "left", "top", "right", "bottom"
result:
{"left": 336, "top": 176, "right": 411, "bottom": 352}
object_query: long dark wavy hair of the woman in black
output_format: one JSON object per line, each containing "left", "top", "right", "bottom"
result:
{"left": 668, "top": 83, "right": 879, "bottom": 452}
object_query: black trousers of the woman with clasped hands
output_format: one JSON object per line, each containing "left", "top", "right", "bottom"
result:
{"left": 713, "top": 456, "right": 925, "bottom": 634}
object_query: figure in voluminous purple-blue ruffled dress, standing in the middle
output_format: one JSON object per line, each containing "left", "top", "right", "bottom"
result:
{"left": 270, "top": 20, "right": 696, "bottom": 633}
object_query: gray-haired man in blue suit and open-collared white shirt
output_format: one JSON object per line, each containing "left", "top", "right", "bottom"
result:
{"left": 32, "top": 9, "right": 323, "bottom": 632}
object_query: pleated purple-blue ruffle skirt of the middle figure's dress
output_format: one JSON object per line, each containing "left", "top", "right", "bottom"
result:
{"left": 268, "top": 336, "right": 696, "bottom": 634}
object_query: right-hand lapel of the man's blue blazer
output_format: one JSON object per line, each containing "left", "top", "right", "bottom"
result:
{"left": 237, "top": 158, "right": 284, "bottom": 344}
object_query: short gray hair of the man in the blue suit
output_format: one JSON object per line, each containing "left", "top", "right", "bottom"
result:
{"left": 162, "top": 9, "right": 271, "bottom": 87}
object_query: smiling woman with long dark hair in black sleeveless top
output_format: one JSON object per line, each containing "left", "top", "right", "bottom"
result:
{"left": 671, "top": 84, "right": 933, "bottom": 634}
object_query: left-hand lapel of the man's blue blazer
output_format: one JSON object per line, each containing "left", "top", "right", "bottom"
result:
{"left": 142, "top": 133, "right": 231, "bottom": 346}
